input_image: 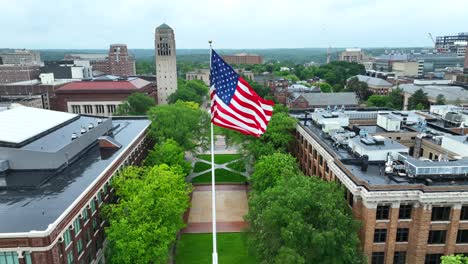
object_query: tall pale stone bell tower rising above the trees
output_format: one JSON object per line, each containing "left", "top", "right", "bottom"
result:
{"left": 154, "top": 23, "right": 177, "bottom": 104}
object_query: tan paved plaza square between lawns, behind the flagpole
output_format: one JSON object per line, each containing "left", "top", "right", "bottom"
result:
{"left": 182, "top": 185, "right": 248, "bottom": 233}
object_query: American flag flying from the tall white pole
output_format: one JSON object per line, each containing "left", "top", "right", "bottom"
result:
{"left": 210, "top": 50, "right": 274, "bottom": 137}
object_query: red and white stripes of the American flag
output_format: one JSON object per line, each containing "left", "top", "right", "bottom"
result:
{"left": 210, "top": 76, "right": 274, "bottom": 137}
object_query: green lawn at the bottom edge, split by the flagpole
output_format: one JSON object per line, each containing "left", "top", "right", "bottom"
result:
{"left": 175, "top": 233, "right": 257, "bottom": 264}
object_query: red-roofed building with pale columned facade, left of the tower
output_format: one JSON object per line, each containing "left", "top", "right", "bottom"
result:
{"left": 53, "top": 76, "right": 156, "bottom": 116}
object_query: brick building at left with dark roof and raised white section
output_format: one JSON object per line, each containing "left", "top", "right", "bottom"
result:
{"left": 0, "top": 107, "right": 151, "bottom": 264}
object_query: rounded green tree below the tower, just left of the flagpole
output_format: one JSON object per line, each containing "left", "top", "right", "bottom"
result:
{"left": 148, "top": 101, "right": 210, "bottom": 150}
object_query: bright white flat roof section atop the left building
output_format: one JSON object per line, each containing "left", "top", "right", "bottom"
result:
{"left": 0, "top": 106, "right": 77, "bottom": 143}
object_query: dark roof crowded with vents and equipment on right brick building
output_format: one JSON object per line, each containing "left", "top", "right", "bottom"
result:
{"left": 295, "top": 107, "right": 468, "bottom": 190}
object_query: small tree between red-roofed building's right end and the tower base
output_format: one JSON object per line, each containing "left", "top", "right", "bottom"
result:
{"left": 116, "top": 93, "right": 156, "bottom": 116}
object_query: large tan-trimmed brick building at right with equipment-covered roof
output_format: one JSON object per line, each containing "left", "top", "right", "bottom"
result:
{"left": 295, "top": 109, "right": 468, "bottom": 264}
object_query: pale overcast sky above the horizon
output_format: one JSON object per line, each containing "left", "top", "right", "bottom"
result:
{"left": 0, "top": 0, "right": 468, "bottom": 49}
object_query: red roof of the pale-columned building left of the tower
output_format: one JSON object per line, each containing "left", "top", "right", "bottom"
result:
{"left": 56, "top": 75, "right": 151, "bottom": 93}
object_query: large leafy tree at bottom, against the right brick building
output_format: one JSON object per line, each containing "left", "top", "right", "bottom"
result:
{"left": 246, "top": 165, "right": 364, "bottom": 264}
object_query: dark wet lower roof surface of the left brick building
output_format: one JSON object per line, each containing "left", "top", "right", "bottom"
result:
{"left": 0, "top": 106, "right": 150, "bottom": 233}
